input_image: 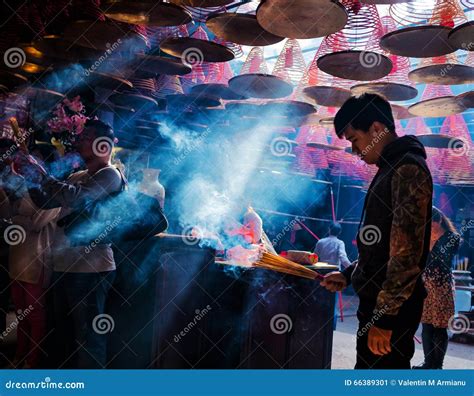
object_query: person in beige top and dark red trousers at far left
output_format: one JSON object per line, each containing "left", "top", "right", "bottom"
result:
{"left": 9, "top": 144, "right": 60, "bottom": 368}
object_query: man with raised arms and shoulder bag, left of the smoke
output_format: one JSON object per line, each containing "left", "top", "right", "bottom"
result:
{"left": 14, "top": 120, "right": 124, "bottom": 368}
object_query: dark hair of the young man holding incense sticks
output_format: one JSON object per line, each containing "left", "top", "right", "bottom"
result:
{"left": 334, "top": 93, "right": 395, "bottom": 138}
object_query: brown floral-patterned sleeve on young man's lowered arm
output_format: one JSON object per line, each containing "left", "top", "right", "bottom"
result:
{"left": 376, "top": 164, "right": 433, "bottom": 328}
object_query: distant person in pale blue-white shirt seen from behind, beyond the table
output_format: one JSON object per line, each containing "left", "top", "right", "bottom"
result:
{"left": 314, "top": 222, "right": 351, "bottom": 271}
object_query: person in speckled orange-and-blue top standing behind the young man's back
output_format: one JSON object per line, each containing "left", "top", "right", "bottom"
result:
{"left": 413, "top": 207, "right": 460, "bottom": 369}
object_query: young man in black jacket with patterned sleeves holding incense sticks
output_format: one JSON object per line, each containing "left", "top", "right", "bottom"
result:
{"left": 321, "top": 94, "right": 433, "bottom": 369}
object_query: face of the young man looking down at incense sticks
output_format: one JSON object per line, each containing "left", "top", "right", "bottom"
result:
{"left": 344, "top": 122, "right": 388, "bottom": 165}
